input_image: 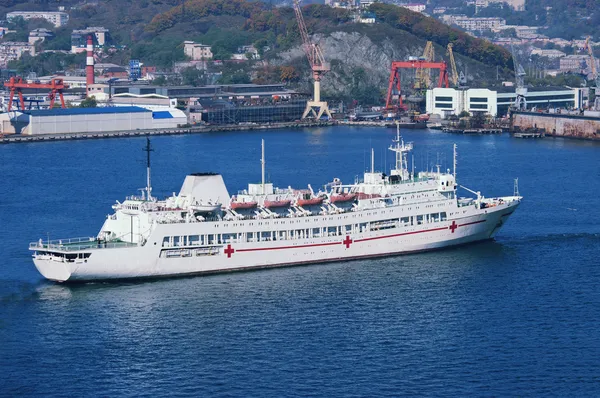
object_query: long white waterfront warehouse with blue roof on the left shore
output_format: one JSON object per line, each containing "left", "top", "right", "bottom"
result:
{"left": 23, "top": 106, "right": 187, "bottom": 135}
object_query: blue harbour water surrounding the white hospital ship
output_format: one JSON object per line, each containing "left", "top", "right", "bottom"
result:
{"left": 0, "top": 127, "right": 600, "bottom": 397}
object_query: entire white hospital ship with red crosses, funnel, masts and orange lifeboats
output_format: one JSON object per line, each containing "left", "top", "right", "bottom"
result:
{"left": 30, "top": 130, "right": 522, "bottom": 282}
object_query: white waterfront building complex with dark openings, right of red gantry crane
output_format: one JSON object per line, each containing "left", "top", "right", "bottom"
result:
{"left": 426, "top": 87, "right": 588, "bottom": 118}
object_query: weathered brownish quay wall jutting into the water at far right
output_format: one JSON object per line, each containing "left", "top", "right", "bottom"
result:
{"left": 511, "top": 112, "right": 600, "bottom": 140}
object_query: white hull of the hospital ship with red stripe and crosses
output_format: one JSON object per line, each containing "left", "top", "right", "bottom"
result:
{"left": 34, "top": 197, "right": 521, "bottom": 282}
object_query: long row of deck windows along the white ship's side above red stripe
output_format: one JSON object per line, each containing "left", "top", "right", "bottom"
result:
{"left": 162, "top": 212, "right": 447, "bottom": 247}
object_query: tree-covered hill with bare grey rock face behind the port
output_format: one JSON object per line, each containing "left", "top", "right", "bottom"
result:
{"left": 0, "top": 0, "right": 512, "bottom": 104}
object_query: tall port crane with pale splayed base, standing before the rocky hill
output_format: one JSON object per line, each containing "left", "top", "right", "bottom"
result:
{"left": 294, "top": 0, "right": 332, "bottom": 120}
